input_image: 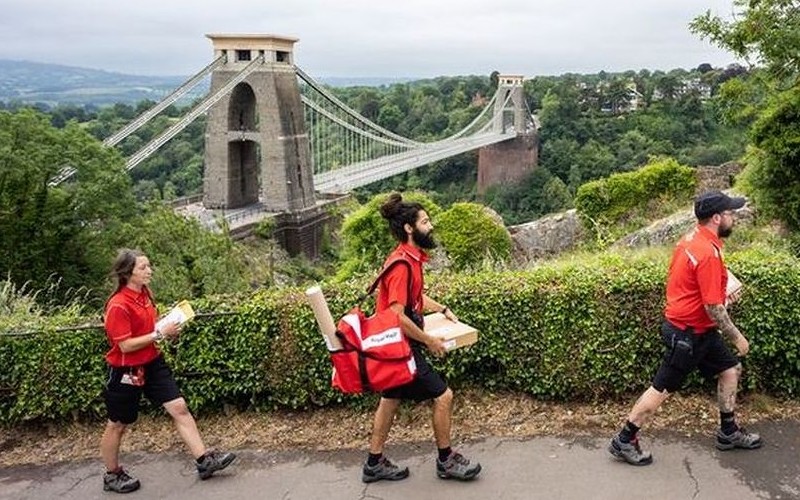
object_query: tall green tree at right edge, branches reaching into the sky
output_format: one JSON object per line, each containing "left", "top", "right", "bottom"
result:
{"left": 691, "top": 0, "right": 800, "bottom": 231}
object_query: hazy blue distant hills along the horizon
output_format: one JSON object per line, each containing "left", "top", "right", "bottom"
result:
{"left": 0, "top": 59, "right": 422, "bottom": 106}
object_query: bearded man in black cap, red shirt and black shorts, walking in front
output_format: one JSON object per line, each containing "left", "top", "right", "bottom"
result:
{"left": 608, "top": 191, "right": 762, "bottom": 465}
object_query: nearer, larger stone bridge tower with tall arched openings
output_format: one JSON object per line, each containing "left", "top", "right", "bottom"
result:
{"left": 203, "top": 34, "right": 315, "bottom": 212}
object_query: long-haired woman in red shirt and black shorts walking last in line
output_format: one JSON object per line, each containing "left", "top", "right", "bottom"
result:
{"left": 100, "top": 249, "right": 236, "bottom": 493}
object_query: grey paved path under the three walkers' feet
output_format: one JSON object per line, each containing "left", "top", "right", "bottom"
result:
{"left": 0, "top": 421, "right": 800, "bottom": 500}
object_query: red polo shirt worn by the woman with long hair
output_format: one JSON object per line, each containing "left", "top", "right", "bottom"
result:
{"left": 105, "top": 286, "right": 159, "bottom": 367}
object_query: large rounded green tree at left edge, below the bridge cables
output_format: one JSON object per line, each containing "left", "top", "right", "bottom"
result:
{"left": 0, "top": 109, "right": 135, "bottom": 298}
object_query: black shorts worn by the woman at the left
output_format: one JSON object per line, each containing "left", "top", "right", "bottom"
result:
{"left": 103, "top": 356, "right": 181, "bottom": 424}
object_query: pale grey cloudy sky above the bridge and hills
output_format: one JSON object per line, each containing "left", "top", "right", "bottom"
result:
{"left": 0, "top": 0, "right": 734, "bottom": 77}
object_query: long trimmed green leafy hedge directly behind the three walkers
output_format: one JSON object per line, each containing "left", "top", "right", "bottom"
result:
{"left": 0, "top": 251, "right": 800, "bottom": 423}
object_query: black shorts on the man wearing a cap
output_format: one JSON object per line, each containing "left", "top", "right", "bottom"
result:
{"left": 653, "top": 321, "right": 739, "bottom": 392}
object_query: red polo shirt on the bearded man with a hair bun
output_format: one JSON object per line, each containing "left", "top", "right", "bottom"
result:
{"left": 375, "top": 243, "right": 428, "bottom": 314}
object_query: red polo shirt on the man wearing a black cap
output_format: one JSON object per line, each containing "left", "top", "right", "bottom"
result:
{"left": 664, "top": 225, "right": 728, "bottom": 332}
